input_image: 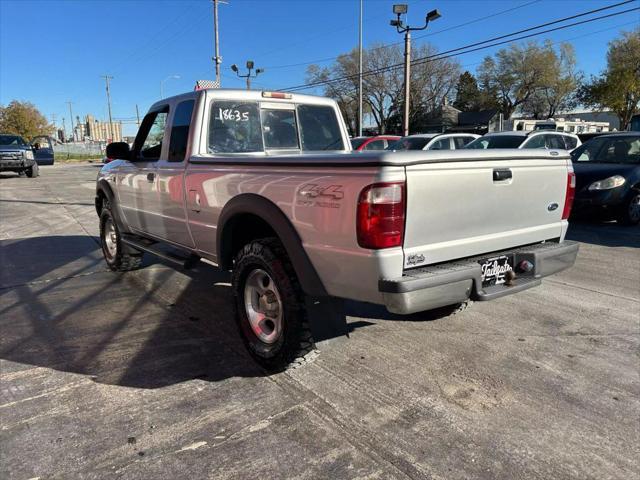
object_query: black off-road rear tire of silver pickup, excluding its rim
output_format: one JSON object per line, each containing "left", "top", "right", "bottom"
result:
{"left": 231, "top": 237, "right": 315, "bottom": 371}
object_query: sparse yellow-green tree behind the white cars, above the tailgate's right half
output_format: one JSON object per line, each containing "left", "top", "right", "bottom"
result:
{"left": 478, "top": 42, "right": 570, "bottom": 118}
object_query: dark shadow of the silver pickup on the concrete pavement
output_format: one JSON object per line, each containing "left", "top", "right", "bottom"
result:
{"left": 0, "top": 236, "right": 456, "bottom": 388}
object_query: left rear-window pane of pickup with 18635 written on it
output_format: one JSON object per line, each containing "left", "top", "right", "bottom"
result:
{"left": 207, "top": 101, "right": 264, "bottom": 153}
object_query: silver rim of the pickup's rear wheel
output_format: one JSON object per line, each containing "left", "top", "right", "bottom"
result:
{"left": 244, "top": 268, "right": 282, "bottom": 343}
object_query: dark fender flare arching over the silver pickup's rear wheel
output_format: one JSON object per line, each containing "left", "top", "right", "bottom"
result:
{"left": 216, "top": 193, "right": 328, "bottom": 297}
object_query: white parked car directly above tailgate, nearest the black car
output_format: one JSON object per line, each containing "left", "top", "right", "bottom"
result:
{"left": 464, "top": 130, "right": 582, "bottom": 150}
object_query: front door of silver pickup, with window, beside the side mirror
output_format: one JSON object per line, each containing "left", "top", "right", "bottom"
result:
{"left": 117, "top": 109, "right": 169, "bottom": 234}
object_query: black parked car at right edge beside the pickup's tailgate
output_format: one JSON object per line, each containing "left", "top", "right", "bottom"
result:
{"left": 571, "top": 132, "right": 640, "bottom": 225}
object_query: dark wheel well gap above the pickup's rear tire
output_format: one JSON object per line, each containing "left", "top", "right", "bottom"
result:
{"left": 219, "top": 213, "right": 279, "bottom": 268}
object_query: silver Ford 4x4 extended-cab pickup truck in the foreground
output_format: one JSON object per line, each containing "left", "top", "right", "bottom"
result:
{"left": 96, "top": 90, "right": 578, "bottom": 368}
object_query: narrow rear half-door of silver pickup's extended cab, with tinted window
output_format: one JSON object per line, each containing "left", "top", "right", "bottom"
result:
{"left": 150, "top": 99, "right": 195, "bottom": 247}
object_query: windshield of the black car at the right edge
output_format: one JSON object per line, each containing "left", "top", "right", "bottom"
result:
{"left": 571, "top": 135, "right": 640, "bottom": 164}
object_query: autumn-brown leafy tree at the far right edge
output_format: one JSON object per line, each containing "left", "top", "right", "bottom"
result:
{"left": 578, "top": 28, "right": 640, "bottom": 130}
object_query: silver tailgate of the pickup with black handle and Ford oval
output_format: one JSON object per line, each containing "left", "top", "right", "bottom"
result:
{"left": 404, "top": 156, "right": 568, "bottom": 268}
